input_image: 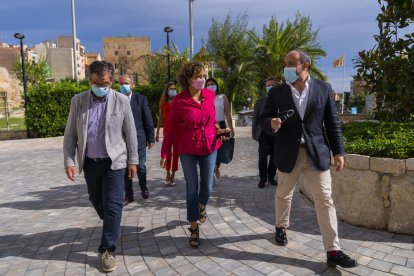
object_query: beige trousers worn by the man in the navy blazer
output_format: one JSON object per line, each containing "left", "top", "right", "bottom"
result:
{"left": 275, "top": 148, "right": 340, "bottom": 251}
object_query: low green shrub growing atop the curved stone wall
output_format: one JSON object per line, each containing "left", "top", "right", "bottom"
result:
{"left": 342, "top": 121, "right": 414, "bottom": 159}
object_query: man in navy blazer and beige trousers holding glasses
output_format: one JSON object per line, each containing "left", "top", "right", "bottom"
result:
{"left": 260, "top": 50, "right": 357, "bottom": 267}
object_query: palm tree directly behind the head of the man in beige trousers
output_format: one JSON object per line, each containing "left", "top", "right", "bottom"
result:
{"left": 247, "top": 13, "right": 326, "bottom": 83}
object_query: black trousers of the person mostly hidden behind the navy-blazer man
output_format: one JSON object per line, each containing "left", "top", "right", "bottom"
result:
{"left": 259, "top": 132, "right": 276, "bottom": 181}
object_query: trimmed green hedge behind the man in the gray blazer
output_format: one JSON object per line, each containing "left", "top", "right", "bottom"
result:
{"left": 26, "top": 81, "right": 163, "bottom": 137}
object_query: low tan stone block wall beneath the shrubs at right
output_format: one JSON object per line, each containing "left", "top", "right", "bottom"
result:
{"left": 299, "top": 154, "right": 414, "bottom": 235}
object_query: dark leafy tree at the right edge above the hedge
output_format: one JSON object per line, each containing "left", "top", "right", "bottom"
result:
{"left": 354, "top": 0, "right": 414, "bottom": 121}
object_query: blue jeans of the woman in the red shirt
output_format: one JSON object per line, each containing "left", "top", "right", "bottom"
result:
{"left": 180, "top": 151, "right": 217, "bottom": 222}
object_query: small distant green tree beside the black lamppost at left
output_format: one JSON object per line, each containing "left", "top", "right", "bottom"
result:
{"left": 14, "top": 60, "right": 50, "bottom": 85}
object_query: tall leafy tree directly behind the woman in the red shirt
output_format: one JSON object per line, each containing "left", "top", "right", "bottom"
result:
{"left": 206, "top": 13, "right": 255, "bottom": 107}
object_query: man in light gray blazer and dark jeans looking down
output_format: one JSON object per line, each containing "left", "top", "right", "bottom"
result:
{"left": 63, "top": 61, "right": 138, "bottom": 272}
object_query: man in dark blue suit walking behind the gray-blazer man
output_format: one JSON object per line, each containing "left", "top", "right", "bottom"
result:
{"left": 119, "top": 74, "right": 155, "bottom": 205}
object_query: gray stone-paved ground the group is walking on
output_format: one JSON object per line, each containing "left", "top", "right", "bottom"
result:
{"left": 0, "top": 128, "right": 414, "bottom": 276}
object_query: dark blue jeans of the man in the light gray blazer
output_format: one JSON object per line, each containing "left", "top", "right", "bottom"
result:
{"left": 83, "top": 158, "right": 125, "bottom": 252}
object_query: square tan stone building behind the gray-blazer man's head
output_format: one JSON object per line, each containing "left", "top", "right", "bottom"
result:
{"left": 103, "top": 36, "right": 151, "bottom": 83}
